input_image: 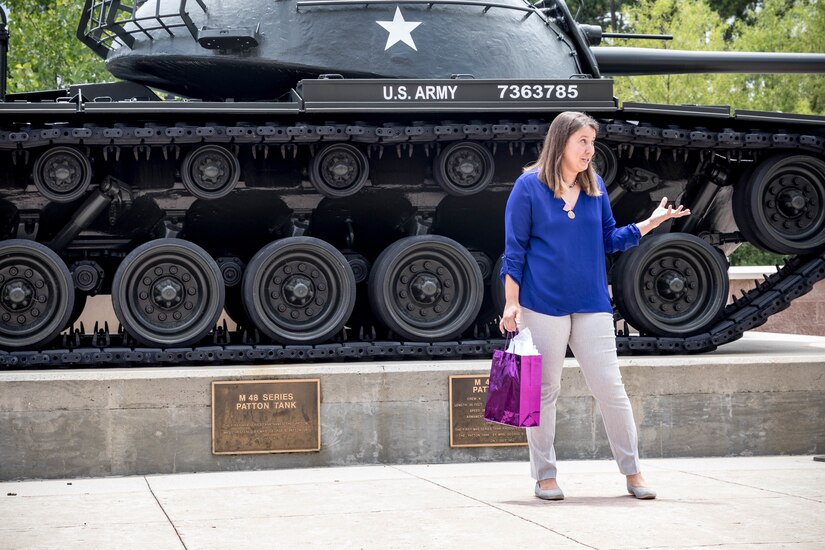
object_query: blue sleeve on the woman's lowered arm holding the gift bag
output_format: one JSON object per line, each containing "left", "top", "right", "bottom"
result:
{"left": 500, "top": 178, "right": 532, "bottom": 286}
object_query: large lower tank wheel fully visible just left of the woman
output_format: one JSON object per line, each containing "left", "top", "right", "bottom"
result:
{"left": 369, "top": 235, "right": 484, "bottom": 341}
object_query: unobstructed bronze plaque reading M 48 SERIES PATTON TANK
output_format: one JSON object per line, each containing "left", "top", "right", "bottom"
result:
{"left": 212, "top": 379, "right": 321, "bottom": 455}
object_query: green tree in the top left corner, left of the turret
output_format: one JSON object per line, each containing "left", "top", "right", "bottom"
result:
{"left": 3, "top": 0, "right": 106, "bottom": 93}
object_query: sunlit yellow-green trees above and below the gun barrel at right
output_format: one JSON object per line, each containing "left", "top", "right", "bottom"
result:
{"left": 615, "top": 0, "right": 825, "bottom": 113}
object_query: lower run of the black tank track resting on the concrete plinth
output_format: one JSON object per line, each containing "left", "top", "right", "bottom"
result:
{"left": 0, "top": 253, "right": 825, "bottom": 369}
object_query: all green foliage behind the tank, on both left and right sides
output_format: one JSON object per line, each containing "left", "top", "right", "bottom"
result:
{"left": 2, "top": 0, "right": 825, "bottom": 265}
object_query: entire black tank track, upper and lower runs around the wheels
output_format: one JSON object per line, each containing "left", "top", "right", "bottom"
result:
{"left": 0, "top": 113, "right": 825, "bottom": 369}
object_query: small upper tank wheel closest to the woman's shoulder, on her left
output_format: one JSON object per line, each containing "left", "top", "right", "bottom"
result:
{"left": 433, "top": 141, "right": 495, "bottom": 197}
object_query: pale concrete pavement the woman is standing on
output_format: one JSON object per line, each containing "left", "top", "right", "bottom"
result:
{"left": 0, "top": 455, "right": 825, "bottom": 550}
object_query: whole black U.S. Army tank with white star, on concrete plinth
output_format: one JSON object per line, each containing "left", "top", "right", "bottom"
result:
{"left": 0, "top": 0, "right": 825, "bottom": 366}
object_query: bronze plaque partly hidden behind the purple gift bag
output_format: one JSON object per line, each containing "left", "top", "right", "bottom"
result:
{"left": 450, "top": 374, "right": 527, "bottom": 447}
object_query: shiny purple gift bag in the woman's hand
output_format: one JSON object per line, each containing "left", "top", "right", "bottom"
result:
{"left": 484, "top": 340, "right": 541, "bottom": 428}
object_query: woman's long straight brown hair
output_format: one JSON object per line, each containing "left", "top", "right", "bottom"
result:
{"left": 524, "top": 111, "right": 602, "bottom": 198}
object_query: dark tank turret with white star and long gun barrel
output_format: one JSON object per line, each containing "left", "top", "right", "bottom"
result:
{"left": 78, "top": 0, "right": 825, "bottom": 100}
